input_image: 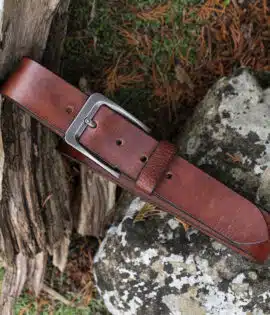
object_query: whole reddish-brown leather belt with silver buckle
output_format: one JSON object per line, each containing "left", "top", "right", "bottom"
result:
{"left": 1, "top": 58, "right": 270, "bottom": 262}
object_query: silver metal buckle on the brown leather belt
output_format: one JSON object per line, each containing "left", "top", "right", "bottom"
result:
{"left": 65, "top": 93, "right": 150, "bottom": 178}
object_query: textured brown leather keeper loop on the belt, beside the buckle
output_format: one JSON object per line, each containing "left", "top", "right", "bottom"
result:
{"left": 136, "top": 141, "right": 177, "bottom": 195}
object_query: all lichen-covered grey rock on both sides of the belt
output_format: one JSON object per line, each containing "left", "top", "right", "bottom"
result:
{"left": 95, "top": 70, "right": 270, "bottom": 315}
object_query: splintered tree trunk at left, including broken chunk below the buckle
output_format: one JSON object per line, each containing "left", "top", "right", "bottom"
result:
{"left": 0, "top": 0, "right": 115, "bottom": 314}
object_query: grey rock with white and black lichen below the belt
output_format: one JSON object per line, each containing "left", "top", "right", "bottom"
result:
{"left": 94, "top": 199, "right": 270, "bottom": 315}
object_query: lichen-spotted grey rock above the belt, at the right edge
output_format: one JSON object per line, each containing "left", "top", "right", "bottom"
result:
{"left": 179, "top": 70, "right": 270, "bottom": 211}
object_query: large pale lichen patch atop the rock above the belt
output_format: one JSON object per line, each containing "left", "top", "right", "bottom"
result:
{"left": 218, "top": 71, "right": 270, "bottom": 174}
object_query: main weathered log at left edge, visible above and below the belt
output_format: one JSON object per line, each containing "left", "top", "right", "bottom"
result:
{"left": 0, "top": 0, "right": 72, "bottom": 314}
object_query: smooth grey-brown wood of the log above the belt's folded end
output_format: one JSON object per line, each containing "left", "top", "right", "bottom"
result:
{"left": 0, "top": 0, "right": 60, "bottom": 79}
